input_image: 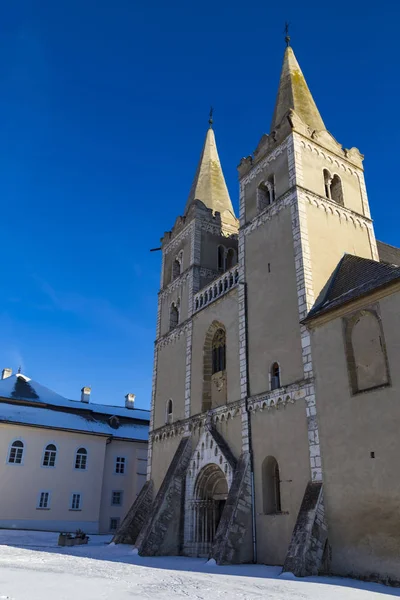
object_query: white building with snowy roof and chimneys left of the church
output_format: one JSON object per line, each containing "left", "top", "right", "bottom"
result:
{"left": 0, "top": 369, "right": 149, "bottom": 533}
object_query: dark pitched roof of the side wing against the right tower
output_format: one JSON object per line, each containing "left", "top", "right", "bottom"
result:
{"left": 304, "top": 254, "right": 400, "bottom": 322}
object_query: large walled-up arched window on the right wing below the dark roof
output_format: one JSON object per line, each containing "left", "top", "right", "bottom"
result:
{"left": 346, "top": 310, "right": 389, "bottom": 394}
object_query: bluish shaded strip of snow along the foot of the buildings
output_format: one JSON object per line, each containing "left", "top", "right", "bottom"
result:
{"left": 0, "top": 529, "right": 400, "bottom": 599}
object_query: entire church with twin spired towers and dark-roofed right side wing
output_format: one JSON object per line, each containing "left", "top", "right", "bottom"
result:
{"left": 114, "top": 38, "right": 400, "bottom": 583}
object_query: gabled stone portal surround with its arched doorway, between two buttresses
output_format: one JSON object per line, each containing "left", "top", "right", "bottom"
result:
{"left": 183, "top": 433, "right": 233, "bottom": 557}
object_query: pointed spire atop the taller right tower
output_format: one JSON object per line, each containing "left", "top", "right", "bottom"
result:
{"left": 271, "top": 44, "right": 325, "bottom": 131}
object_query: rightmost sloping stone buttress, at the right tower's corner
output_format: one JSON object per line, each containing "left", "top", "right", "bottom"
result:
{"left": 283, "top": 481, "right": 328, "bottom": 577}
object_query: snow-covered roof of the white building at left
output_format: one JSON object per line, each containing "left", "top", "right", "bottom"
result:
{"left": 0, "top": 374, "right": 149, "bottom": 440}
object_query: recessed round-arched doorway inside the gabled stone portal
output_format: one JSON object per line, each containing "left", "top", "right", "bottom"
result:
{"left": 188, "top": 464, "right": 228, "bottom": 556}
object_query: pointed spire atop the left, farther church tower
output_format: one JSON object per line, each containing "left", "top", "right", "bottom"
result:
{"left": 185, "top": 108, "right": 235, "bottom": 218}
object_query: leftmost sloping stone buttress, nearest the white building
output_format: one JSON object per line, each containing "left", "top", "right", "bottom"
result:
{"left": 112, "top": 481, "right": 153, "bottom": 544}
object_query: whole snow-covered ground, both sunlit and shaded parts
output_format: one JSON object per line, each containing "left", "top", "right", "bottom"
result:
{"left": 0, "top": 530, "right": 400, "bottom": 600}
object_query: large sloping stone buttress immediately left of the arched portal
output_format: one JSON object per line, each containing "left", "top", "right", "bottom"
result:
{"left": 136, "top": 437, "right": 192, "bottom": 556}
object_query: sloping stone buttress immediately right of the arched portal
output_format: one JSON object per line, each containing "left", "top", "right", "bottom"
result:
{"left": 212, "top": 452, "right": 253, "bottom": 565}
